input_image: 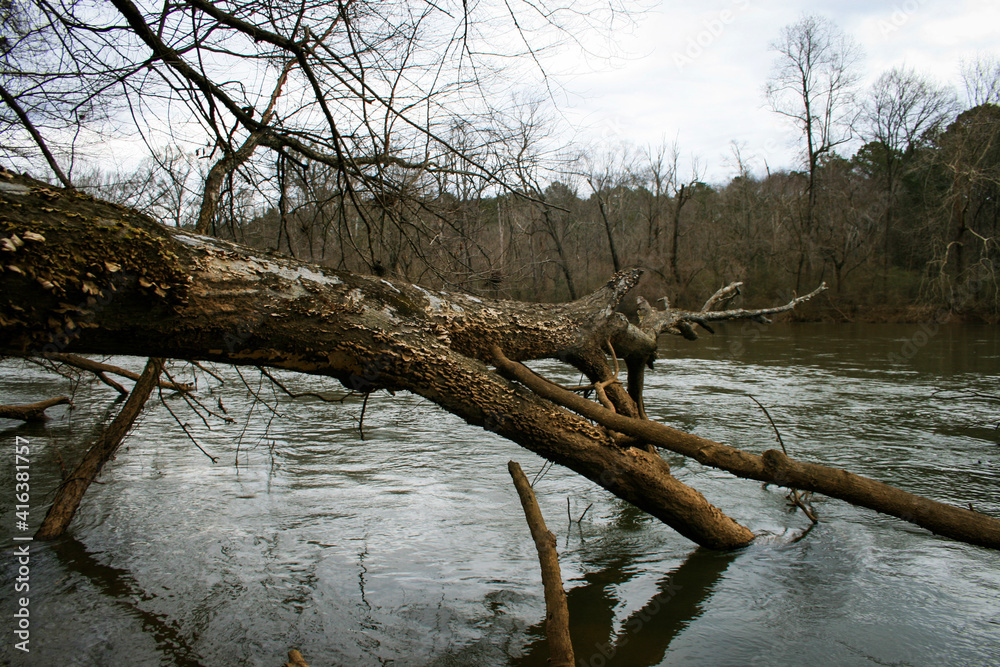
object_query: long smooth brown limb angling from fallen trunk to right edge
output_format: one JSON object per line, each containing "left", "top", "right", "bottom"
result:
{"left": 494, "top": 349, "right": 1000, "bottom": 549}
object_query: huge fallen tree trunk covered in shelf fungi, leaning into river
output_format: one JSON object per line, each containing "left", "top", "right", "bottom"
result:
{"left": 0, "top": 170, "right": 992, "bottom": 549}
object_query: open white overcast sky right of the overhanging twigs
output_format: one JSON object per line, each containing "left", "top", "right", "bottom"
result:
{"left": 550, "top": 0, "right": 1000, "bottom": 182}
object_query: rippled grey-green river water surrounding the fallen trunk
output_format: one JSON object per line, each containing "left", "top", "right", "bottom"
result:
{"left": 0, "top": 324, "right": 1000, "bottom": 667}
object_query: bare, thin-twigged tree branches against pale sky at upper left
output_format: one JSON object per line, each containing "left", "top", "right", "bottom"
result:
{"left": 0, "top": 0, "right": 617, "bottom": 280}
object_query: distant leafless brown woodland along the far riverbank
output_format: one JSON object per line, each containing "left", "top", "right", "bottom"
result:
{"left": 180, "top": 104, "right": 1000, "bottom": 324}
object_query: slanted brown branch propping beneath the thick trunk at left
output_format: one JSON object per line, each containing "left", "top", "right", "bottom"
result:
{"left": 35, "top": 359, "right": 163, "bottom": 540}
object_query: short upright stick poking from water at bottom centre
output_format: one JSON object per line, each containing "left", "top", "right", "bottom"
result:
{"left": 507, "top": 461, "right": 573, "bottom": 667}
